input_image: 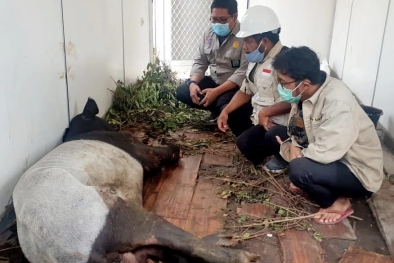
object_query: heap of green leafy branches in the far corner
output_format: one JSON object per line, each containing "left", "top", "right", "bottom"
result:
{"left": 105, "top": 59, "right": 204, "bottom": 134}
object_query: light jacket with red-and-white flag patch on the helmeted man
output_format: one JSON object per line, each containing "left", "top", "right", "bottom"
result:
{"left": 240, "top": 41, "right": 289, "bottom": 126}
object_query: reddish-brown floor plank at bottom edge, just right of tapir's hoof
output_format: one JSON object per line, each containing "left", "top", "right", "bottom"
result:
{"left": 278, "top": 230, "right": 325, "bottom": 263}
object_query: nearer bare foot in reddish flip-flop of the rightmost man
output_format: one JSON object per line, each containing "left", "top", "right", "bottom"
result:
{"left": 314, "top": 197, "right": 354, "bottom": 224}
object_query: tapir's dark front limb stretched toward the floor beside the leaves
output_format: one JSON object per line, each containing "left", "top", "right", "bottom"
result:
{"left": 65, "top": 131, "right": 181, "bottom": 172}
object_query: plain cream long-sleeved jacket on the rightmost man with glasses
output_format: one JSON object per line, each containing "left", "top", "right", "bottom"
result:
{"left": 280, "top": 76, "right": 384, "bottom": 192}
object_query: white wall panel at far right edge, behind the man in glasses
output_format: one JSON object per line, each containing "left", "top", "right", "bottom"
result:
{"left": 372, "top": 1, "right": 394, "bottom": 138}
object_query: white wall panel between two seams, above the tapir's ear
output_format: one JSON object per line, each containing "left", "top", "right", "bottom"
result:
{"left": 63, "top": 0, "right": 124, "bottom": 118}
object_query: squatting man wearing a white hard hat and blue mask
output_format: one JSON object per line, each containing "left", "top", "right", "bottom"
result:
{"left": 218, "top": 6, "right": 290, "bottom": 173}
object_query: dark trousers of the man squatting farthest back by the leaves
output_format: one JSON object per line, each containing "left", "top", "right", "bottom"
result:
{"left": 176, "top": 76, "right": 238, "bottom": 115}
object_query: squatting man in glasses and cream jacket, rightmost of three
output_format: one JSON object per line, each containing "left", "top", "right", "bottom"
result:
{"left": 273, "top": 47, "right": 384, "bottom": 224}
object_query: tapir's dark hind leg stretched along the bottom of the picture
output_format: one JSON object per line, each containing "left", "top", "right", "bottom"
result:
{"left": 93, "top": 197, "right": 259, "bottom": 263}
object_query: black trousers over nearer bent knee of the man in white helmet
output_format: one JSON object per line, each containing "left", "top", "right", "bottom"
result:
{"left": 237, "top": 125, "right": 289, "bottom": 165}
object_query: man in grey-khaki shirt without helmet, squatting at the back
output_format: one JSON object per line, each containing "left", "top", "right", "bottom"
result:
{"left": 177, "top": 0, "right": 248, "bottom": 121}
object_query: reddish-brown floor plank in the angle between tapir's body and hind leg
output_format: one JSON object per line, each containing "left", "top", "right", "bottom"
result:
{"left": 152, "top": 181, "right": 194, "bottom": 219}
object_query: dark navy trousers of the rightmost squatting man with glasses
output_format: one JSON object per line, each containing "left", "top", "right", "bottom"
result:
{"left": 289, "top": 158, "right": 372, "bottom": 208}
